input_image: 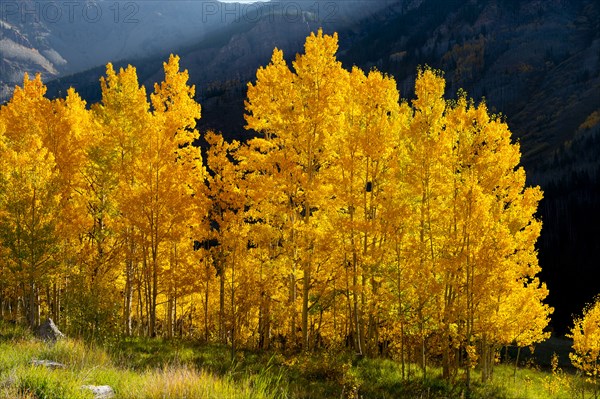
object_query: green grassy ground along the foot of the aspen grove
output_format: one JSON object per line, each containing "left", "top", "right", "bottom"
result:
{"left": 0, "top": 323, "right": 593, "bottom": 399}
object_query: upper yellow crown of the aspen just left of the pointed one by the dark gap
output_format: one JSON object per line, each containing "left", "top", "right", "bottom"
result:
{"left": 90, "top": 63, "right": 152, "bottom": 324}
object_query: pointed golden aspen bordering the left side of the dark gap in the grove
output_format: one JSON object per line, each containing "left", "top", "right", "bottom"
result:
{"left": 148, "top": 55, "right": 206, "bottom": 335}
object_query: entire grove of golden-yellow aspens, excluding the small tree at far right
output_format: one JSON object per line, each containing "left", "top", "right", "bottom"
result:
{"left": 0, "top": 31, "right": 552, "bottom": 381}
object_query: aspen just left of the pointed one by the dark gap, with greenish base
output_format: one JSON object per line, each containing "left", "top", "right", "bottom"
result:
{"left": 72, "top": 64, "right": 149, "bottom": 337}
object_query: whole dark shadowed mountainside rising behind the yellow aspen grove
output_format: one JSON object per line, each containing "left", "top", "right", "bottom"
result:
{"left": 44, "top": 0, "right": 600, "bottom": 332}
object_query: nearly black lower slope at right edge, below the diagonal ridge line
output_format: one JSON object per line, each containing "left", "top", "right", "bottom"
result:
{"left": 532, "top": 122, "right": 600, "bottom": 331}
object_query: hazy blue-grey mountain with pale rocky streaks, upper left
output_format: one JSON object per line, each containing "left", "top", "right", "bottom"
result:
{"left": 0, "top": 0, "right": 244, "bottom": 100}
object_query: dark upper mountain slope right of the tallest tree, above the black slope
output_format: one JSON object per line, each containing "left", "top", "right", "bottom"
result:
{"left": 341, "top": 0, "right": 600, "bottom": 166}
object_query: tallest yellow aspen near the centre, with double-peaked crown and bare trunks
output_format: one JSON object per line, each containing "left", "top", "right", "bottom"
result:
{"left": 246, "top": 30, "right": 347, "bottom": 348}
